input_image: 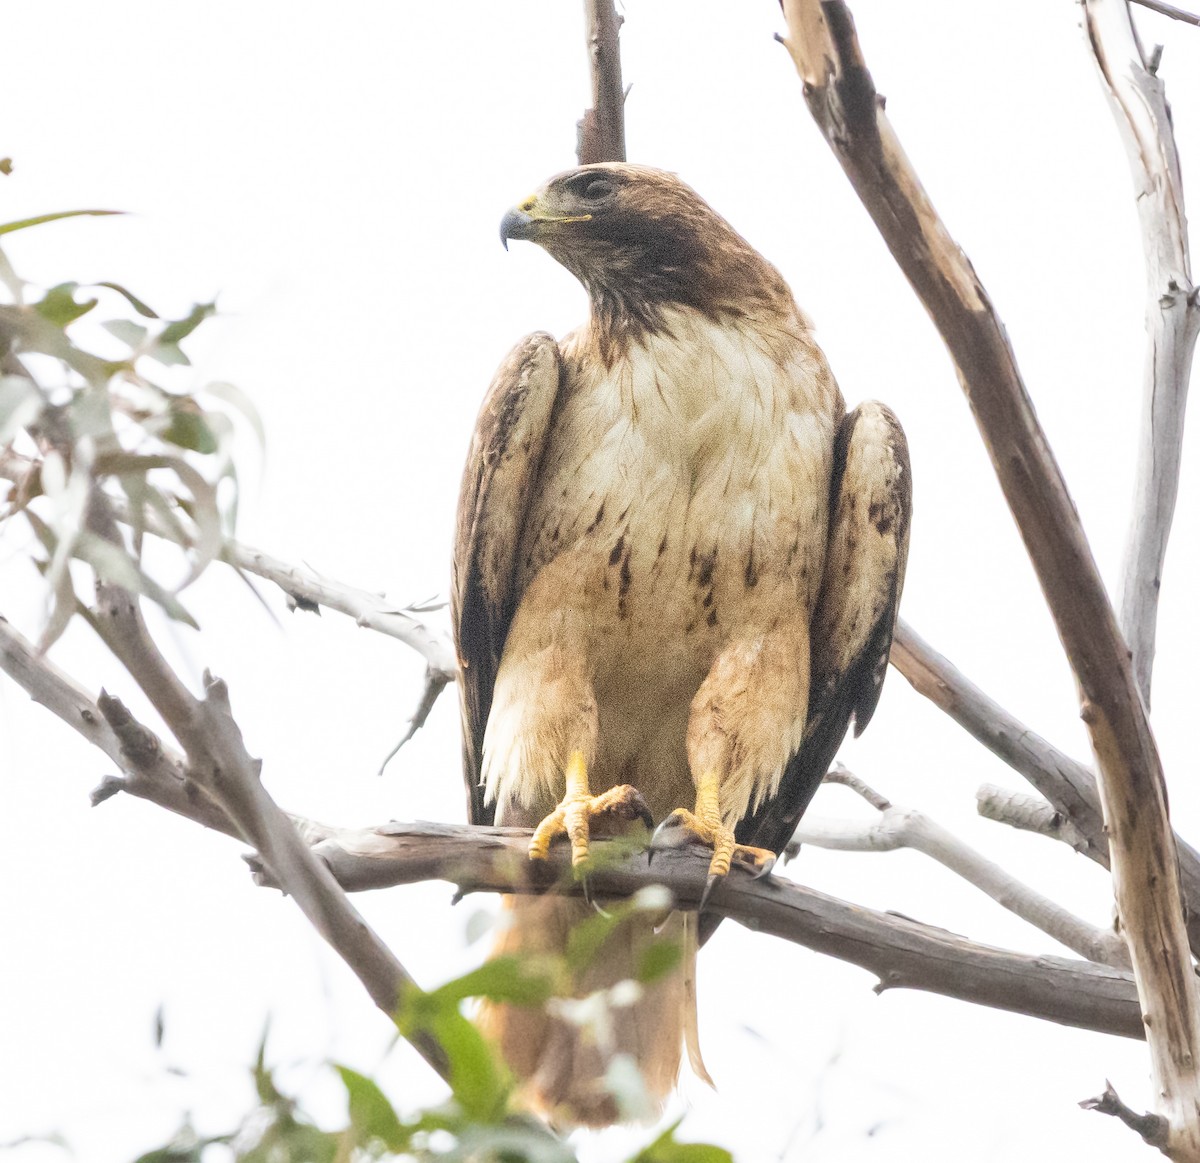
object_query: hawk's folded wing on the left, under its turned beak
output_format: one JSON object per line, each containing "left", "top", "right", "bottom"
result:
{"left": 450, "top": 331, "right": 563, "bottom": 823}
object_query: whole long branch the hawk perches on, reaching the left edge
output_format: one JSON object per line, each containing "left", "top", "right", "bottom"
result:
{"left": 0, "top": 619, "right": 1141, "bottom": 1037}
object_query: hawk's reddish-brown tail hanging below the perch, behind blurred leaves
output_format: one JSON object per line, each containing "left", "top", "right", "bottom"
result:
{"left": 479, "top": 897, "right": 708, "bottom": 1127}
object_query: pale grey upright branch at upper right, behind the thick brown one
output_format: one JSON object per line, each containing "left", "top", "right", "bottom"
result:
{"left": 1084, "top": 0, "right": 1200, "bottom": 706}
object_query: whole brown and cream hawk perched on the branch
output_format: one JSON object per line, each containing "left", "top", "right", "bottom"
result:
{"left": 452, "top": 163, "right": 911, "bottom": 1125}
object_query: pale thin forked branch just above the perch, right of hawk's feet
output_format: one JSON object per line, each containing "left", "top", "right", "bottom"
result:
{"left": 787, "top": 765, "right": 1129, "bottom": 969}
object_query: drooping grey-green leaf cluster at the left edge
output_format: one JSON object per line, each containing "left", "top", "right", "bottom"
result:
{"left": 0, "top": 210, "right": 262, "bottom": 647}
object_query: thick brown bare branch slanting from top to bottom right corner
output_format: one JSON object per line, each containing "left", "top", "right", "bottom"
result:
{"left": 784, "top": 0, "right": 1200, "bottom": 1159}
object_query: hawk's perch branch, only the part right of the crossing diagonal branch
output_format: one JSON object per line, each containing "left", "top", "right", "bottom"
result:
{"left": 250, "top": 823, "right": 1142, "bottom": 1038}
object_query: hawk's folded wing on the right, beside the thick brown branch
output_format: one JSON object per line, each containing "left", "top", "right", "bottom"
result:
{"left": 737, "top": 401, "right": 912, "bottom": 852}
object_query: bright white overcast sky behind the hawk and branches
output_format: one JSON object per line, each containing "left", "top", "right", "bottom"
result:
{"left": 0, "top": 0, "right": 1200, "bottom": 1163}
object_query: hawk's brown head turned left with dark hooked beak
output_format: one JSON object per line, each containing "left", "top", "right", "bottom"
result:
{"left": 500, "top": 162, "right": 794, "bottom": 340}
